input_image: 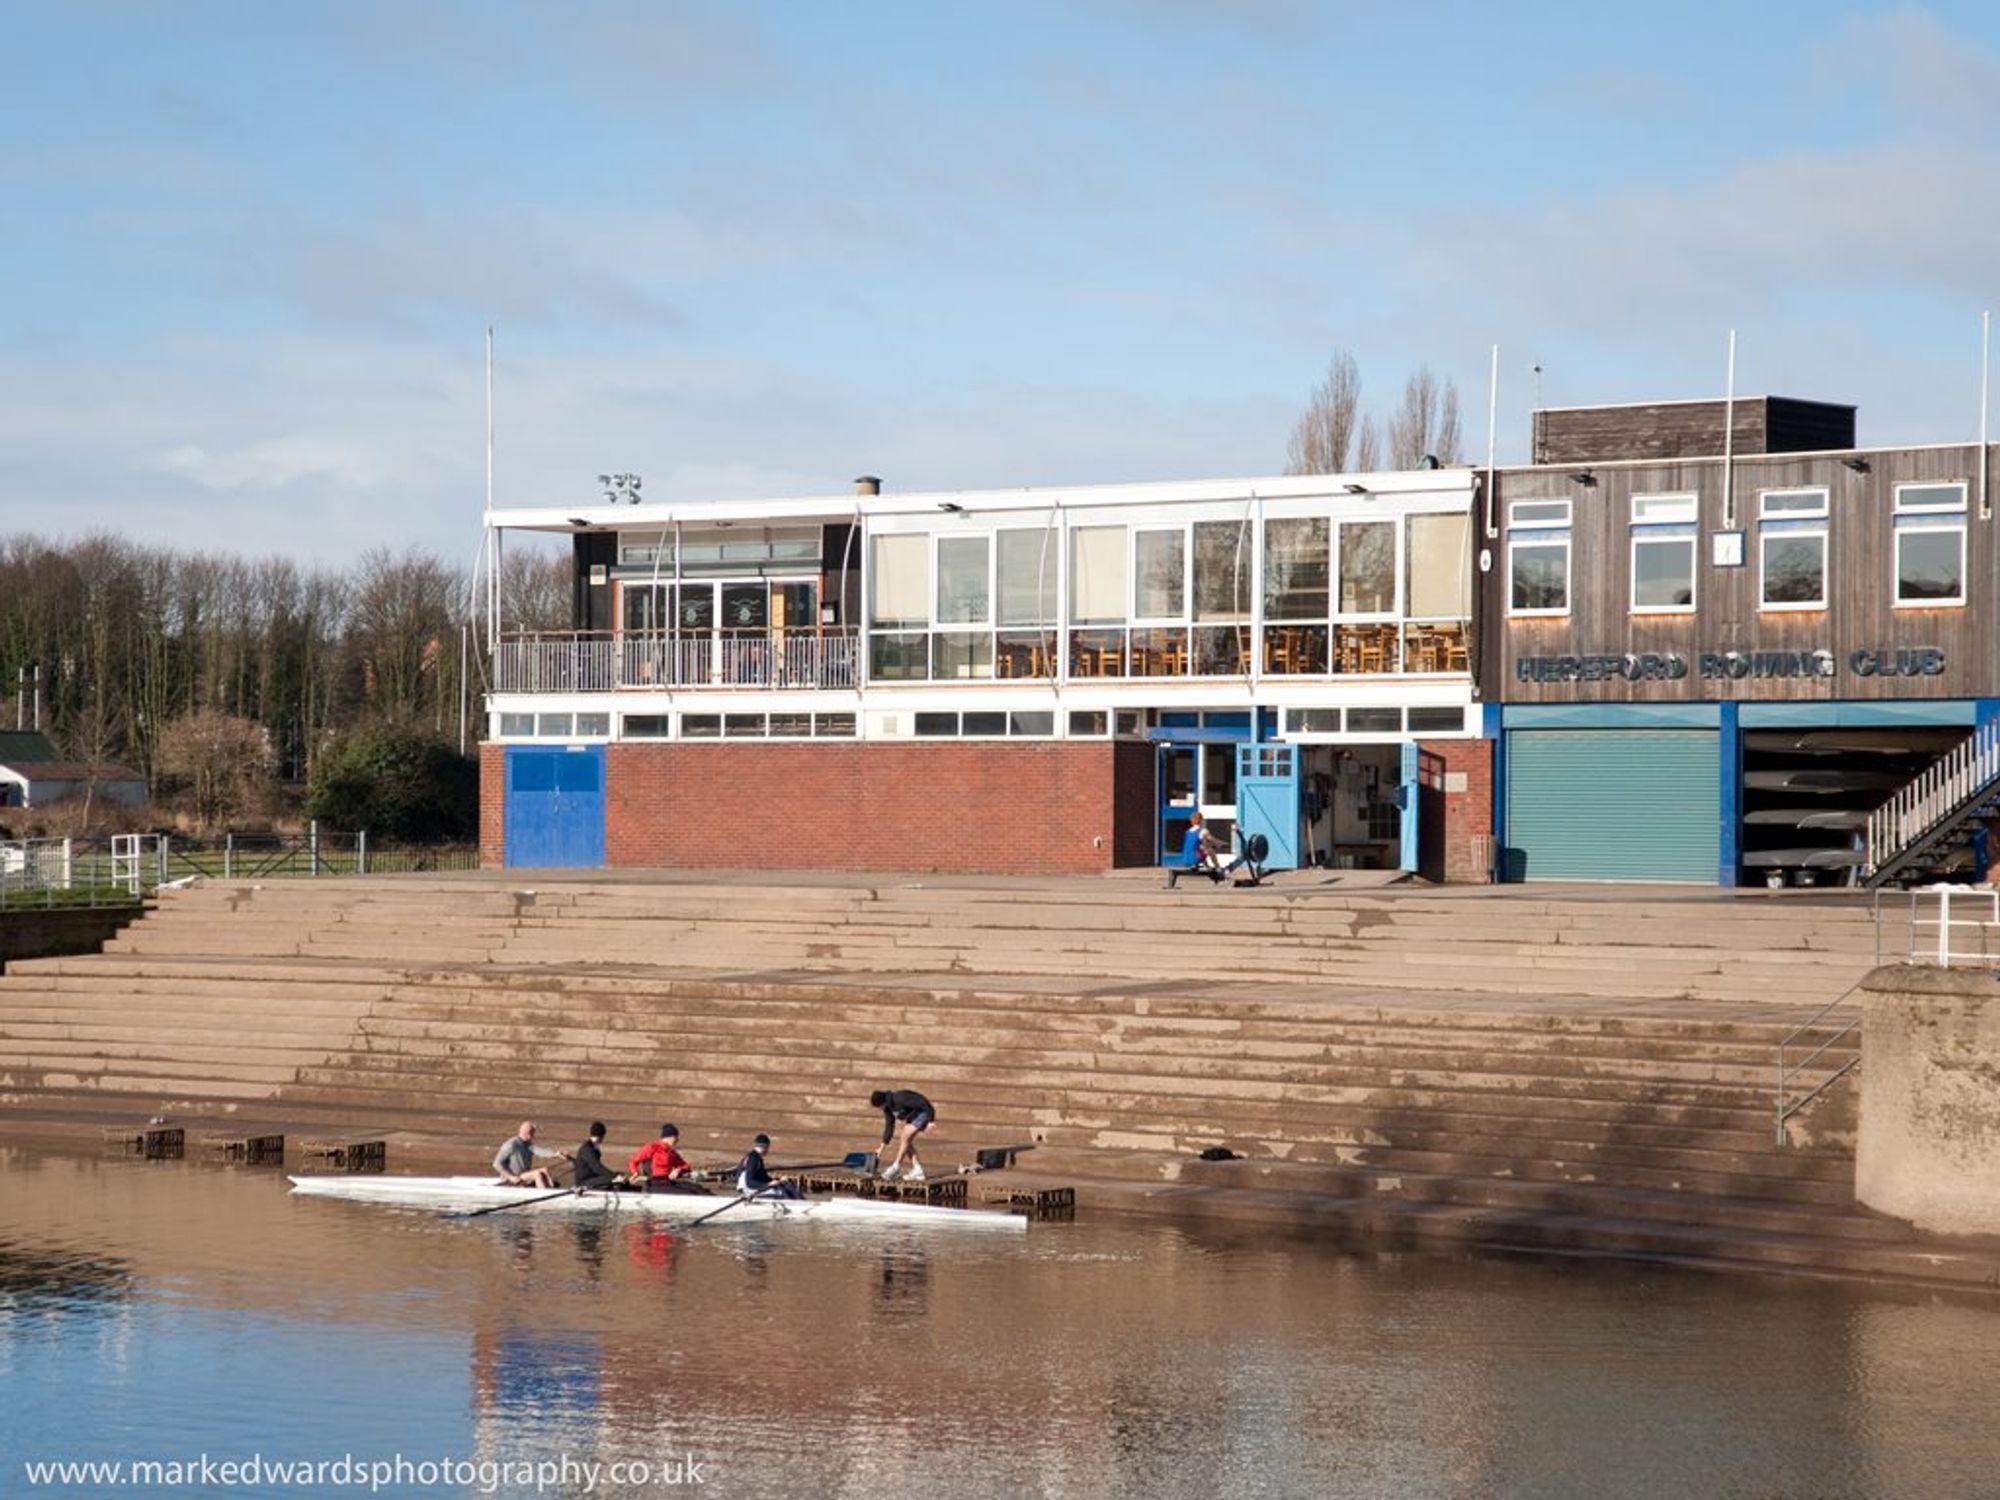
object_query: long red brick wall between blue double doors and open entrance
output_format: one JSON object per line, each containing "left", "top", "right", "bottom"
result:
{"left": 606, "top": 740, "right": 1152, "bottom": 874}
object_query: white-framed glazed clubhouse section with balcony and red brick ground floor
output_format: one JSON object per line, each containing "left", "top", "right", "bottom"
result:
{"left": 482, "top": 468, "right": 1490, "bottom": 878}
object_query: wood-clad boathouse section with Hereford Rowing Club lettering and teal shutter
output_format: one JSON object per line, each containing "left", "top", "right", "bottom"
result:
{"left": 1478, "top": 398, "right": 2000, "bottom": 886}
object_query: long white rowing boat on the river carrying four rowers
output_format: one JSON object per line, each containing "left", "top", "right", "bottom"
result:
{"left": 292, "top": 1174, "right": 1028, "bottom": 1230}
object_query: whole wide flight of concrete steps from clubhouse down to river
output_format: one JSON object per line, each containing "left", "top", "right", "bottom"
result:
{"left": 0, "top": 880, "right": 1968, "bottom": 1284}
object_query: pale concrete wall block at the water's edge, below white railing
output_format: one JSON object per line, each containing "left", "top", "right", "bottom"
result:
{"left": 1854, "top": 966, "right": 2000, "bottom": 1234}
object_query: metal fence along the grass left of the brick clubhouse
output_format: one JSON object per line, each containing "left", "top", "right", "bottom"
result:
{"left": 0, "top": 826, "right": 480, "bottom": 910}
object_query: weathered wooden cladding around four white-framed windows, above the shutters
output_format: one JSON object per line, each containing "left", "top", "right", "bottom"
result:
{"left": 1478, "top": 446, "right": 2000, "bottom": 704}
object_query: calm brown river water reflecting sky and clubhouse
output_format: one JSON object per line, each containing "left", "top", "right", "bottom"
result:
{"left": 0, "top": 1148, "right": 2000, "bottom": 1500}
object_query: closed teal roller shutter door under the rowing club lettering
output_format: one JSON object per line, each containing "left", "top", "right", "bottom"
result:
{"left": 1506, "top": 730, "right": 1722, "bottom": 884}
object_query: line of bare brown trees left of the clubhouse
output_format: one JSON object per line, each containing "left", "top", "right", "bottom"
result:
{"left": 0, "top": 536, "right": 570, "bottom": 800}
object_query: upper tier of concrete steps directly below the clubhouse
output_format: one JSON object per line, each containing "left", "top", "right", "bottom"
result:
{"left": 94, "top": 878, "right": 1874, "bottom": 1004}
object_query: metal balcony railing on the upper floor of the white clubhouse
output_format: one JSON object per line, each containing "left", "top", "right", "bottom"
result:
{"left": 494, "top": 630, "right": 860, "bottom": 692}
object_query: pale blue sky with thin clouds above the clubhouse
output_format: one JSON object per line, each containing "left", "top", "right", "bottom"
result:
{"left": 0, "top": 0, "right": 2000, "bottom": 564}
